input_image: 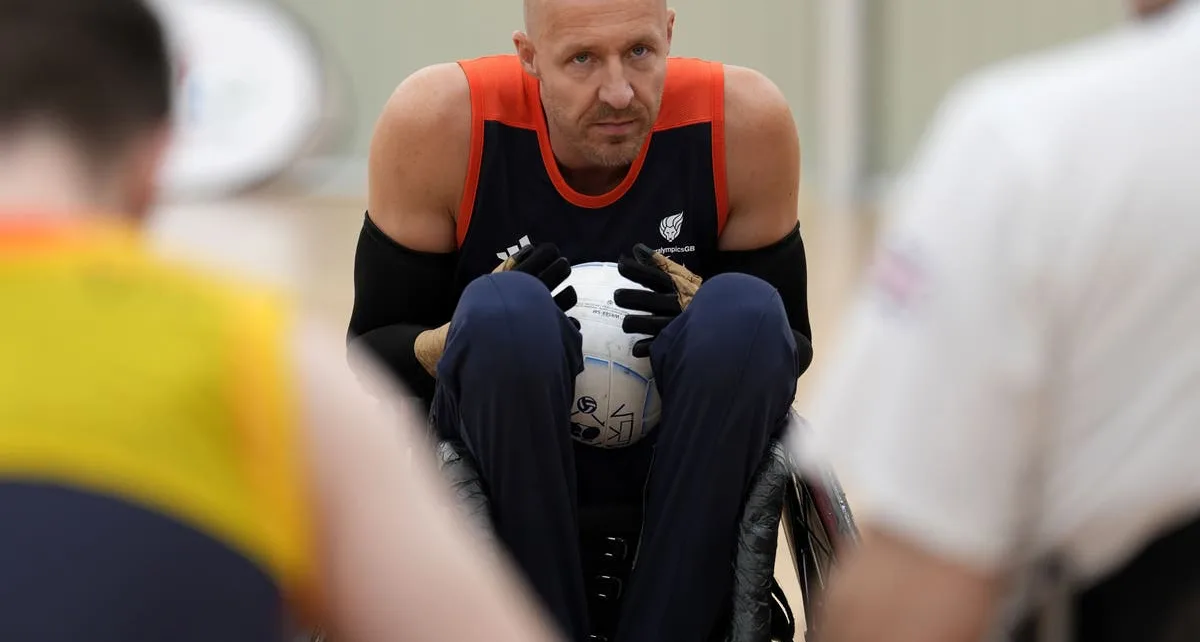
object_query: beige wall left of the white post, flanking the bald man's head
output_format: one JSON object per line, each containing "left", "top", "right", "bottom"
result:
{"left": 281, "top": 0, "right": 815, "bottom": 165}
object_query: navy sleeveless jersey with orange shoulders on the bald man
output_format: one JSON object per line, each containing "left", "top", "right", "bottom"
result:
{"left": 456, "top": 55, "right": 728, "bottom": 290}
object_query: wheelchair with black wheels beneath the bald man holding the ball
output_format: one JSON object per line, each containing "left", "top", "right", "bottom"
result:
{"left": 310, "top": 413, "right": 858, "bottom": 642}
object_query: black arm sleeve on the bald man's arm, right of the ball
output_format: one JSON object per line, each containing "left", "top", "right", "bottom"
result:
{"left": 701, "top": 223, "right": 812, "bottom": 373}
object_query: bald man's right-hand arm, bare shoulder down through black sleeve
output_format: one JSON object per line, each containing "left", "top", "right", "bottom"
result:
{"left": 713, "top": 66, "right": 812, "bottom": 371}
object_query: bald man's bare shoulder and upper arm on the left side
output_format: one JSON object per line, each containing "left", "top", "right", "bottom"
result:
{"left": 367, "top": 62, "right": 470, "bottom": 252}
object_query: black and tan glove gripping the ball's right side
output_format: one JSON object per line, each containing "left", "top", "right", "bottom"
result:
{"left": 612, "top": 244, "right": 703, "bottom": 359}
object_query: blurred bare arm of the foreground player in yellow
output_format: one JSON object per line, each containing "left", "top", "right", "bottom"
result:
{"left": 295, "top": 325, "right": 562, "bottom": 642}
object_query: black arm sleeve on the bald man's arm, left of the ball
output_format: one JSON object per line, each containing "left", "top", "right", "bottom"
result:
{"left": 347, "top": 212, "right": 457, "bottom": 403}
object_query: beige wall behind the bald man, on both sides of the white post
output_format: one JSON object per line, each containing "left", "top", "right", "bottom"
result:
{"left": 280, "top": 0, "right": 1124, "bottom": 189}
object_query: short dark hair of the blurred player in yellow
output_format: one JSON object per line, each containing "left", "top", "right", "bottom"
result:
{"left": 0, "top": 0, "right": 173, "bottom": 156}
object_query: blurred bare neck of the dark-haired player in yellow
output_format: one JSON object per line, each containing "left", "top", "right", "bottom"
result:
{"left": 0, "top": 134, "right": 116, "bottom": 217}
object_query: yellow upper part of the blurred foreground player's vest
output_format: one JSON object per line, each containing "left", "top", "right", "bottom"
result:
{"left": 0, "top": 221, "right": 314, "bottom": 619}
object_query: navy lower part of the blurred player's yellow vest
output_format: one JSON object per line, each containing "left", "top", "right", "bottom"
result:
{"left": 0, "top": 479, "right": 280, "bottom": 642}
